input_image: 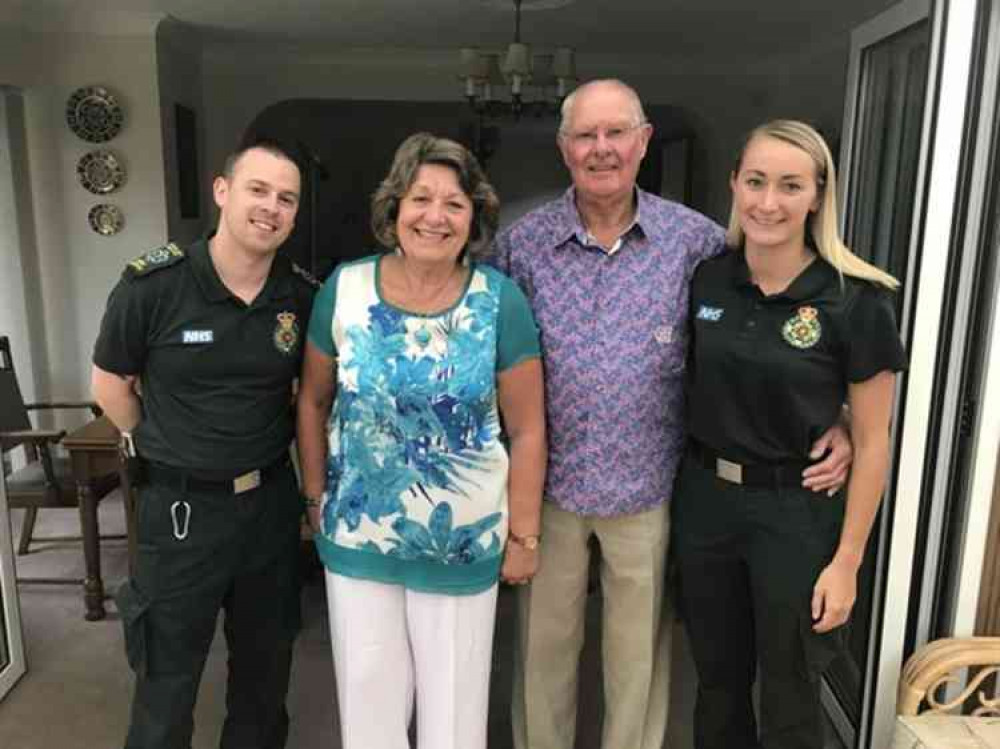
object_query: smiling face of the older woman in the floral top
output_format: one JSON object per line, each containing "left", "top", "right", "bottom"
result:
{"left": 396, "top": 164, "right": 473, "bottom": 263}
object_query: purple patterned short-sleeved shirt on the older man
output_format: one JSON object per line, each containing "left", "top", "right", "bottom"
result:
{"left": 494, "top": 188, "right": 724, "bottom": 517}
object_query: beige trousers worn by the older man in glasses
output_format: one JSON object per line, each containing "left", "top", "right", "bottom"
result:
{"left": 512, "top": 502, "right": 671, "bottom": 749}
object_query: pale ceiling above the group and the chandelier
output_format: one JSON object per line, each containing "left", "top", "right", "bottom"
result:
{"left": 0, "top": 0, "right": 895, "bottom": 60}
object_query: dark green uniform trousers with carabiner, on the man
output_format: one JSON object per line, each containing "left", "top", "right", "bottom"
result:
{"left": 117, "top": 465, "right": 302, "bottom": 749}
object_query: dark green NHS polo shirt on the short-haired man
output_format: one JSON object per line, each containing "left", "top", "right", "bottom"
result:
{"left": 94, "top": 239, "right": 315, "bottom": 478}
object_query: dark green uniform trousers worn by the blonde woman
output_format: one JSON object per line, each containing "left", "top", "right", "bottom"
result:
{"left": 671, "top": 458, "right": 844, "bottom": 749}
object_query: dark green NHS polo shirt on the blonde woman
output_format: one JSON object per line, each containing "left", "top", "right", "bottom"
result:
{"left": 687, "top": 250, "right": 906, "bottom": 463}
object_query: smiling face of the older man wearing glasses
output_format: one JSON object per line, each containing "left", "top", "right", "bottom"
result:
{"left": 559, "top": 83, "right": 652, "bottom": 201}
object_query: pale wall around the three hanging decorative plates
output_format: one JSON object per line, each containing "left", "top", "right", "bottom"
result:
{"left": 0, "top": 28, "right": 167, "bottom": 398}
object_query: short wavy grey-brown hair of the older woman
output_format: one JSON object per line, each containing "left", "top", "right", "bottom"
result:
{"left": 372, "top": 133, "right": 500, "bottom": 258}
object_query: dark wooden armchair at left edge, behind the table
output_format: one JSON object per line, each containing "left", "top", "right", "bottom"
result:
{"left": 0, "top": 336, "right": 119, "bottom": 583}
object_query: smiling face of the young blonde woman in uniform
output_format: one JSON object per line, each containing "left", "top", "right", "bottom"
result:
{"left": 729, "top": 135, "right": 822, "bottom": 248}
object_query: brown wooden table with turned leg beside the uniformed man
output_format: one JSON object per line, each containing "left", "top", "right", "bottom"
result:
{"left": 60, "top": 416, "right": 135, "bottom": 621}
